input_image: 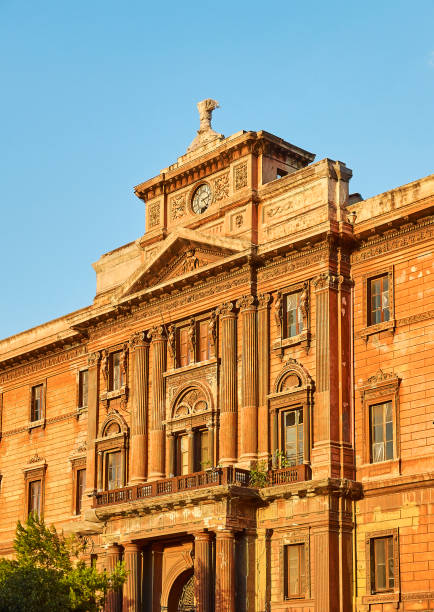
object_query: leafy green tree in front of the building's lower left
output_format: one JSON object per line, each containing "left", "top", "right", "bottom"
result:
{"left": 0, "top": 514, "right": 127, "bottom": 612}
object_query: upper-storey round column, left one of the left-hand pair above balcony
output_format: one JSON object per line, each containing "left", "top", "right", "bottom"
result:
{"left": 130, "top": 332, "right": 149, "bottom": 484}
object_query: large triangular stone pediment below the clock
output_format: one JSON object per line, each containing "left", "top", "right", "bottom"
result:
{"left": 117, "top": 228, "right": 250, "bottom": 299}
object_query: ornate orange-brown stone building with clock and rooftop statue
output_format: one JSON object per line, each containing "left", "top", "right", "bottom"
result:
{"left": 0, "top": 100, "right": 434, "bottom": 612}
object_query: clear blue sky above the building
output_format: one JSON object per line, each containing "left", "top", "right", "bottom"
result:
{"left": 0, "top": 0, "right": 434, "bottom": 338}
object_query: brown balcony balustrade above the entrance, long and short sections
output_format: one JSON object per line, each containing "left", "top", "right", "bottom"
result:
{"left": 93, "top": 465, "right": 310, "bottom": 508}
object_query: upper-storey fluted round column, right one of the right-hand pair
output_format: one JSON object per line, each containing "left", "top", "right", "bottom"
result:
{"left": 237, "top": 295, "right": 258, "bottom": 464}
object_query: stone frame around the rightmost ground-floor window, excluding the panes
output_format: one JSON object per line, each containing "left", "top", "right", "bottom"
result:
{"left": 363, "top": 528, "right": 400, "bottom": 604}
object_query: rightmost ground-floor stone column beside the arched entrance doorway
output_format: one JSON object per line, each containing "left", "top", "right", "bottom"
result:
{"left": 215, "top": 529, "right": 235, "bottom": 612}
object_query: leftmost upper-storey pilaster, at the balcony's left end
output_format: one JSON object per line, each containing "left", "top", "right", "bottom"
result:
{"left": 83, "top": 352, "right": 100, "bottom": 509}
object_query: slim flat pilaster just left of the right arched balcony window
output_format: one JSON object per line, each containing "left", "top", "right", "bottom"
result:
{"left": 258, "top": 293, "right": 271, "bottom": 461}
